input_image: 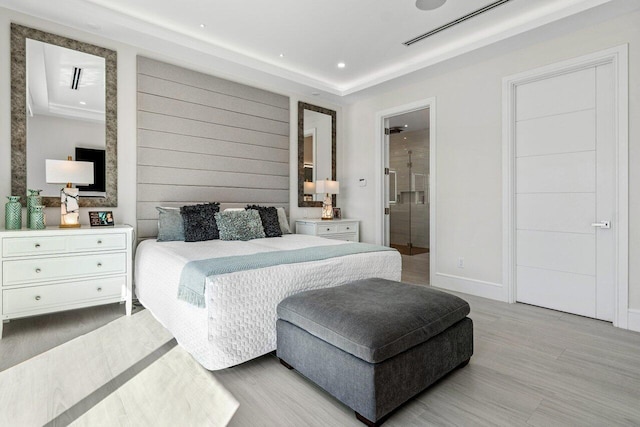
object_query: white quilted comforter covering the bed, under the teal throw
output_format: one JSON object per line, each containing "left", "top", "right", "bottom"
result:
{"left": 135, "top": 234, "right": 402, "bottom": 370}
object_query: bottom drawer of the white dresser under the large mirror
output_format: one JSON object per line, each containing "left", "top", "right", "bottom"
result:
{"left": 2, "top": 277, "right": 126, "bottom": 315}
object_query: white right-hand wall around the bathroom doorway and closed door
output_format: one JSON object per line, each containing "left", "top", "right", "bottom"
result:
{"left": 341, "top": 12, "right": 640, "bottom": 308}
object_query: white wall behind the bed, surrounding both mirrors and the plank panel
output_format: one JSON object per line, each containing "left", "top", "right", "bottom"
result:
{"left": 0, "top": 8, "right": 342, "bottom": 231}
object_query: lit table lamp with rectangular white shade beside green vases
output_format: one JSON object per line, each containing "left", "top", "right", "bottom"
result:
{"left": 45, "top": 156, "right": 93, "bottom": 228}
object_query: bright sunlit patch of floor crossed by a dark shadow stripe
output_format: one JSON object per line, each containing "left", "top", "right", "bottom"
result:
{"left": 0, "top": 310, "right": 238, "bottom": 426}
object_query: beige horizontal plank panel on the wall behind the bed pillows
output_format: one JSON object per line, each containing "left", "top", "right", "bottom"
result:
{"left": 136, "top": 56, "right": 289, "bottom": 238}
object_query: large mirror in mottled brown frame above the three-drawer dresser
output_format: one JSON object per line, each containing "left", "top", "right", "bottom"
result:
{"left": 11, "top": 23, "right": 118, "bottom": 207}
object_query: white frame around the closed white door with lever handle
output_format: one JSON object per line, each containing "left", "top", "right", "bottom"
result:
{"left": 502, "top": 44, "right": 629, "bottom": 329}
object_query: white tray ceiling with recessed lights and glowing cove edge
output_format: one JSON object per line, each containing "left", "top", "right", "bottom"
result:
{"left": 0, "top": 0, "right": 640, "bottom": 96}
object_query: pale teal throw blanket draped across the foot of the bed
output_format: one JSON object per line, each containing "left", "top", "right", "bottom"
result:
{"left": 178, "top": 243, "right": 395, "bottom": 307}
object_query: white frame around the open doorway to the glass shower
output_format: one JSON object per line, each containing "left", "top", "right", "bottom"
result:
{"left": 374, "top": 97, "right": 437, "bottom": 283}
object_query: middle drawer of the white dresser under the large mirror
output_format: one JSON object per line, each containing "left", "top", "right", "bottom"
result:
{"left": 2, "top": 252, "right": 126, "bottom": 286}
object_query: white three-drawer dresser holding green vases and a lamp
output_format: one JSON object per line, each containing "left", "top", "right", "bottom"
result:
{"left": 0, "top": 225, "right": 132, "bottom": 338}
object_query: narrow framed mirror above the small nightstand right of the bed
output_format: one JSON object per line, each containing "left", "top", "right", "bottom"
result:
{"left": 298, "top": 102, "right": 336, "bottom": 208}
